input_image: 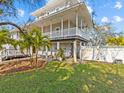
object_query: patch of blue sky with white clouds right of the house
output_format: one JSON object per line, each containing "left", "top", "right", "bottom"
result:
{"left": 87, "top": 0, "right": 124, "bottom": 32}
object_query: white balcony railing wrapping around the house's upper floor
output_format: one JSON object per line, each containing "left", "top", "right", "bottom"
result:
{"left": 43, "top": 27, "right": 89, "bottom": 40}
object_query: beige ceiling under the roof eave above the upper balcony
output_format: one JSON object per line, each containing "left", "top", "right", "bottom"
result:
{"left": 35, "top": 4, "right": 92, "bottom": 28}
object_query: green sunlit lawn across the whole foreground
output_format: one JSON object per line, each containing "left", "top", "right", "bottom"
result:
{"left": 0, "top": 62, "right": 124, "bottom": 93}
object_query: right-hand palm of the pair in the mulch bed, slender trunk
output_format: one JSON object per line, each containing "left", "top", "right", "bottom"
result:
{"left": 29, "top": 26, "right": 51, "bottom": 64}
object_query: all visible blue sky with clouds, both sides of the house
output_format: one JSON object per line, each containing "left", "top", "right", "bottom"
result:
{"left": 8, "top": 0, "right": 124, "bottom": 32}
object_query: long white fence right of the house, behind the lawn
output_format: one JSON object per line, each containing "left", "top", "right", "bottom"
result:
{"left": 81, "top": 46, "right": 124, "bottom": 63}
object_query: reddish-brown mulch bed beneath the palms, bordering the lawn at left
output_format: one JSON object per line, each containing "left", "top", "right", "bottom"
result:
{"left": 0, "top": 60, "right": 46, "bottom": 76}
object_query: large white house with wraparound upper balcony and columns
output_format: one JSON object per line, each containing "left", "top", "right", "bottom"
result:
{"left": 1, "top": 0, "right": 92, "bottom": 62}
